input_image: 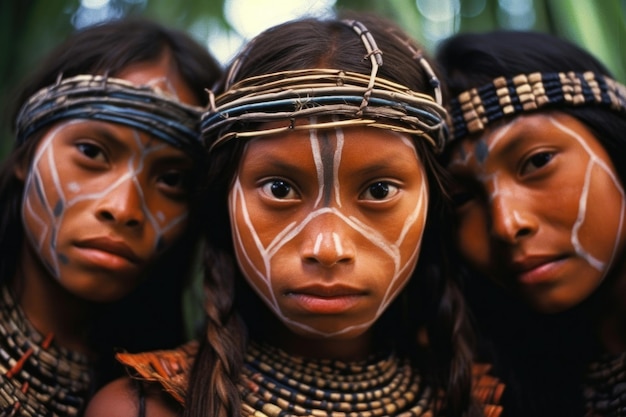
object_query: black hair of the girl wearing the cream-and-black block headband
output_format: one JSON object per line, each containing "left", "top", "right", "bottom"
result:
{"left": 437, "top": 30, "right": 626, "bottom": 416}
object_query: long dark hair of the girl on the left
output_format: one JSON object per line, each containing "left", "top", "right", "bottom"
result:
{"left": 0, "top": 18, "right": 221, "bottom": 385}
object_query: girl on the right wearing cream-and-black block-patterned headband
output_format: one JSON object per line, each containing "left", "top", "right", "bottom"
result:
{"left": 439, "top": 32, "right": 626, "bottom": 416}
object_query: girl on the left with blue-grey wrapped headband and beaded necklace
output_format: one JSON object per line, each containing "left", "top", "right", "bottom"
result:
{"left": 0, "top": 15, "right": 220, "bottom": 416}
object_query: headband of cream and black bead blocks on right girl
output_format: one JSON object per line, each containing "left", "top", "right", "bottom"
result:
{"left": 449, "top": 72, "right": 626, "bottom": 140}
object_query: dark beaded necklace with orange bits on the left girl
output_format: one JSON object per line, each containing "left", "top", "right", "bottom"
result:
{"left": 0, "top": 287, "right": 92, "bottom": 416}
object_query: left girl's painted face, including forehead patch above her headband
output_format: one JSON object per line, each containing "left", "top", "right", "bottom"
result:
{"left": 22, "top": 57, "right": 196, "bottom": 301}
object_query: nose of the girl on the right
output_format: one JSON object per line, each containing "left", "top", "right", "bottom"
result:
{"left": 491, "top": 192, "right": 537, "bottom": 244}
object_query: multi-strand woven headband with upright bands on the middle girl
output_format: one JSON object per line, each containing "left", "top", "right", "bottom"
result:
{"left": 201, "top": 21, "right": 448, "bottom": 150}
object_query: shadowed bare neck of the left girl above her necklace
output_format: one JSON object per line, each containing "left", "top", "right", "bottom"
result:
{"left": 12, "top": 242, "right": 92, "bottom": 354}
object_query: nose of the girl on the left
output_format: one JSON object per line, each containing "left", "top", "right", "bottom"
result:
{"left": 96, "top": 179, "right": 145, "bottom": 228}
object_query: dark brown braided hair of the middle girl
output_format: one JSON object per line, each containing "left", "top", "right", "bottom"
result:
{"left": 183, "top": 10, "right": 481, "bottom": 417}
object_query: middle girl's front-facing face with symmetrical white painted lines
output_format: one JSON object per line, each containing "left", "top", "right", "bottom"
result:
{"left": 229, "top": 127, "right": 428, "bottom": 340}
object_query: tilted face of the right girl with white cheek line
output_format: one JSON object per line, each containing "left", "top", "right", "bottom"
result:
{"left": 449, "top": 112, "right": 625, "bottom": 312}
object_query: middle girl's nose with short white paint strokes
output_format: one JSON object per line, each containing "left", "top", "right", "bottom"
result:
{"left": 301, "top": 214, "right": 356, "bottom": 267}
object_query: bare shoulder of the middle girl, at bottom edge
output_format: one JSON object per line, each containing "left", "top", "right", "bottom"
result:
{"left": 84, "top": 377, "right": 181, "bottom": 417}
